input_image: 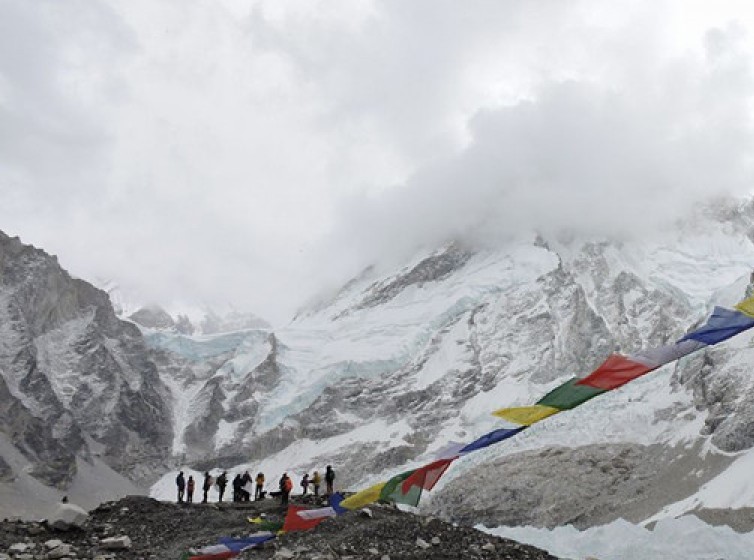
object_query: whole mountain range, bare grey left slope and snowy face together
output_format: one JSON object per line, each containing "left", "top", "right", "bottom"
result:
{"left": 0, "top": 200, "right": 754, "bottom": 544}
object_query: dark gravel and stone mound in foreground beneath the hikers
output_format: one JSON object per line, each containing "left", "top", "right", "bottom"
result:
{"left": 0, "top": 496, "right": 556, "bottom": 560}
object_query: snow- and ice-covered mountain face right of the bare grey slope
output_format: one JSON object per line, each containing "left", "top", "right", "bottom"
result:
{"left": 142, "top": 199, "right": 754, "bottom": 527}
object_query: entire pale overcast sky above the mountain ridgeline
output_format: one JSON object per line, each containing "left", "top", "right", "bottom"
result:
{"left": 0, "top": 0, "right": 754, "bottom": 323}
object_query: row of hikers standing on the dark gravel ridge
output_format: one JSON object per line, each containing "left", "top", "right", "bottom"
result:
{"left": 175, "top": 465, "right": 335, "bottom": 506}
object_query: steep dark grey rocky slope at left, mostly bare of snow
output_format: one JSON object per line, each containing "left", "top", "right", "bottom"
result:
{"left": 0, "top": 233, "right": 172, "bottom": 496}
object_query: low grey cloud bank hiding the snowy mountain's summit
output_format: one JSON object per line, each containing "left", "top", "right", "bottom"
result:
{"left": 324, "top": 15, "right": 754, "bottom": 272}
